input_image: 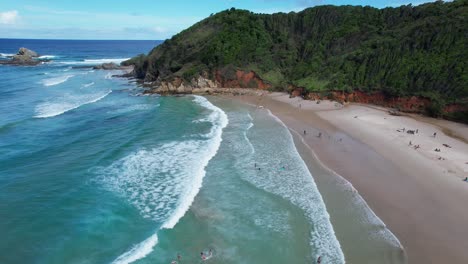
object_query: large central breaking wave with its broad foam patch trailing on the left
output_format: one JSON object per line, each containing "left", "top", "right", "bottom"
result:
{"left": 101, "top": 96, "right": 228, "bottom": 263}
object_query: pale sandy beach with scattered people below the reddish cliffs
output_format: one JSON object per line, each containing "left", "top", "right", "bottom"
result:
{"left": 233, "top": 93, "right": 468, "bottom": 264}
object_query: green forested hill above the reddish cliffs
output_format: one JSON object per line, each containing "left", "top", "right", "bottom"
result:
{"left": 127, "top": 0, "right": 468, "bottom": 120}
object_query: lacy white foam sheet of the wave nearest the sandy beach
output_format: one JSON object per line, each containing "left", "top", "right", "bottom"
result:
{"left": 243, "top": 109, "right": 345, "bottom": 264}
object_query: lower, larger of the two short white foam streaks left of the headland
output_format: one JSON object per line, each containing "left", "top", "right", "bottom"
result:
{"left": 34, "top": 90, "right": 112, "bottom": 118}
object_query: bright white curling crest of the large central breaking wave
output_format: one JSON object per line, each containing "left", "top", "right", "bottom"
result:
{"left": 112, "top": 95, "right": 229, "bottom": 264}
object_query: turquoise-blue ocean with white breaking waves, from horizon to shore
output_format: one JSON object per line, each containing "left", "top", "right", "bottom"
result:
{"left": 0, "top": 39, "right": 404, "bottom": 264}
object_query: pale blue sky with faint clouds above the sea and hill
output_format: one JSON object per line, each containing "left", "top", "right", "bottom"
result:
{"left": 0, "top": 0, "right": 431, "bottom": 40}
